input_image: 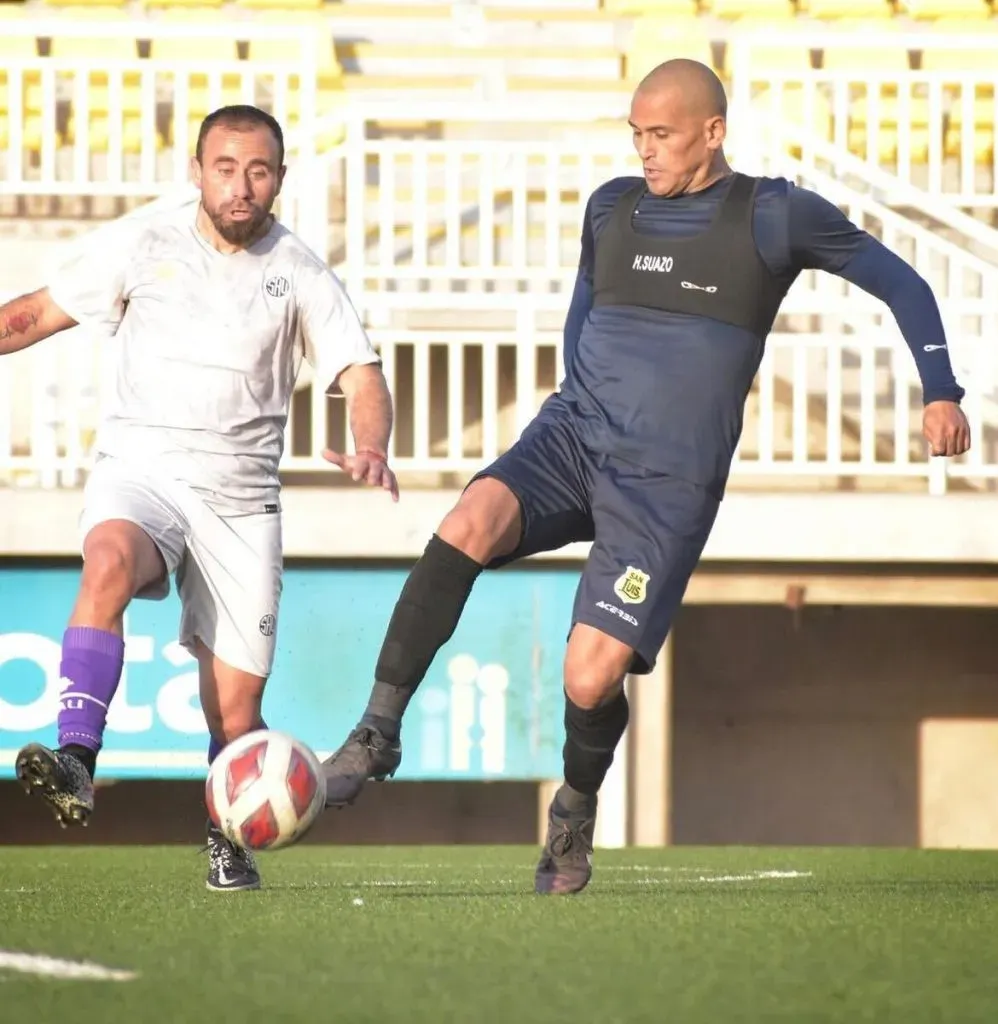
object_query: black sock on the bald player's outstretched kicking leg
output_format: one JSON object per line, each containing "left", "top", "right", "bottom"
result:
{"left": 360, "top": 534, "right": 482, "bottom": 739}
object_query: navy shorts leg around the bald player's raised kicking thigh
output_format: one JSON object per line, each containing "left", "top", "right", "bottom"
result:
{"left": 475, "top": 397, "right": 596, "bottom": 568}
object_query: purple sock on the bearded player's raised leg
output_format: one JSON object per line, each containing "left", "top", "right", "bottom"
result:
{"left": 58, "top": 626, "right": 125, "bottom": 754}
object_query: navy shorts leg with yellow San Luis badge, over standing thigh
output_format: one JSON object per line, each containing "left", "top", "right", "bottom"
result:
{"left": 573, "top": 462, "right": 719, "bottom": 674}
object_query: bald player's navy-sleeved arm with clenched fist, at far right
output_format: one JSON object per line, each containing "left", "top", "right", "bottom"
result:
{"left": 789, "top": 188, "right": 970, "bottom": 456}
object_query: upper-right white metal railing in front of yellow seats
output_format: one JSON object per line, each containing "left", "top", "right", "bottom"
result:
{"left": 729, "top": 32, "right": 998, "bottom": 207}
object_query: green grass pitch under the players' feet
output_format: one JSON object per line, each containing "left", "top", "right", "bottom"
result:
{"left": 0, "top": 845, "right": 998, "bottom": 1024}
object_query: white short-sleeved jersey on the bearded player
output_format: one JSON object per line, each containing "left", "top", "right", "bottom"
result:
{"left": 49, "top": 203, "right": 379, "bottom": 511}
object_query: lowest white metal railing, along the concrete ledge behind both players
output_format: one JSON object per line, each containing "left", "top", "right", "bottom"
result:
{"left": 0, "top": 288, "right": 998, "bottom": 489}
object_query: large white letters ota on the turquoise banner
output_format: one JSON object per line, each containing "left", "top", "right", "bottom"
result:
{"left": 0, "top": 617, "right": 208, "bottom": 735}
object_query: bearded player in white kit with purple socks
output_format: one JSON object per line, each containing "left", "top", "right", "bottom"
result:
{"left": 0, "top": 105, "right": 398, "bottom": 890}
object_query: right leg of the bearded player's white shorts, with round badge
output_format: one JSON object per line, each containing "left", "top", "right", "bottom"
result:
{"left": 177, "top": 503, "right": 283, "bottom": 678}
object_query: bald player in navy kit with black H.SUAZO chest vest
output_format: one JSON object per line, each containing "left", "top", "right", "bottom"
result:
{"left": 326, "top": 60, "right": 969, "bottom": 893}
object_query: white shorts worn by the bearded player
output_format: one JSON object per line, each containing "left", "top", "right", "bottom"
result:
{"left": 80, "top": 457, "right": 283, "bottom": 678}
